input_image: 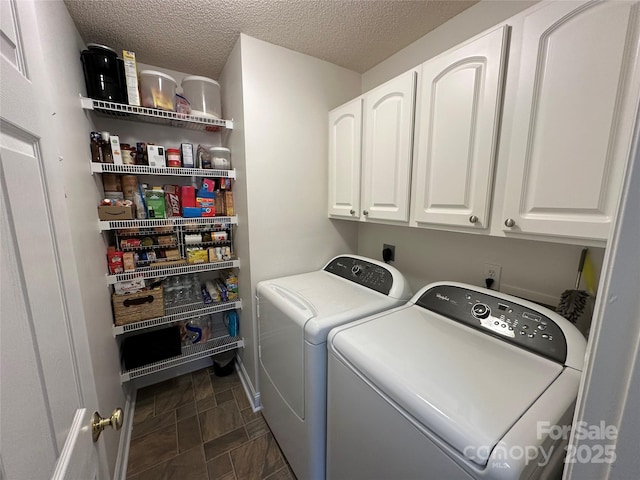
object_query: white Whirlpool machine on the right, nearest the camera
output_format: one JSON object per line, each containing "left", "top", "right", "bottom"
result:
{"left": 327, "top": 282, "right": 586, "bottom": 480}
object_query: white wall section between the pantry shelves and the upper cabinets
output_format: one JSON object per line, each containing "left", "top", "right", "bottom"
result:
{"left": 229, "top": 35, "right": 360, "bottom": 398}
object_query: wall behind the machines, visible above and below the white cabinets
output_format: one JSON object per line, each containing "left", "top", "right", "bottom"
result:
{"left": 358, "top": 1, "right": 604, "bottom": 306}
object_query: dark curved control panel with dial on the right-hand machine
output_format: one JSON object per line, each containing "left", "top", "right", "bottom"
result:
{"left": 417, "top": 285, "right": 567, "bottom": 363}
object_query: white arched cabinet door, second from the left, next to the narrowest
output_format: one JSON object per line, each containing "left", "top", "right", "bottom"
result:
{"left": 362, "top": 69, "right": 418, "bottom": 222}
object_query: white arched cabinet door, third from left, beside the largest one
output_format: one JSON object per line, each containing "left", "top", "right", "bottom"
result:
{"left": 412, "top": 27, "right": 507, "bottom": 228}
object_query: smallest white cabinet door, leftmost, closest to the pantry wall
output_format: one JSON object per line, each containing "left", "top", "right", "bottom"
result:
{"left": 329, "top": 98, "right": 362, "bottom": 219}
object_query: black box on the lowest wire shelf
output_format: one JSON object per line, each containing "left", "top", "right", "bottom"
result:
{"left": 122, "top": 326, "right": 182, "bottom": 370}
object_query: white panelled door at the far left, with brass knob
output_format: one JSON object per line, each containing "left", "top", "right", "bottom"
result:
{"left": 0, "top": 0, "right": 108, "bottom": 480}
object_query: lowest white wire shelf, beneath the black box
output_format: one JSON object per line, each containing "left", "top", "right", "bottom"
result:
{"left": 120, "top": 335, "right": 244, "bottom": 383}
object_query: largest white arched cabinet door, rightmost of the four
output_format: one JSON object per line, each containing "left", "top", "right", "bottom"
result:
{"left": 502, "top": 2, "right": 640, "bottom": 240}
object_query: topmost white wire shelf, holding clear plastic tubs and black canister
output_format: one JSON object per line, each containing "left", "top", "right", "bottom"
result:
{"left": 80, "top": 97, "right": 233, "bottom": 132}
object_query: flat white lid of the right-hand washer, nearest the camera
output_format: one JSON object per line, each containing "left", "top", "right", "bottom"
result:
{"left": 330, "top": 305, "right": 563, "bottom": 465}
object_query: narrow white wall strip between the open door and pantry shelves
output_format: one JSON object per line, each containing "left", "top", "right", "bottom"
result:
{"left": 37, "top": 2, "right": 125, "bottom": 472}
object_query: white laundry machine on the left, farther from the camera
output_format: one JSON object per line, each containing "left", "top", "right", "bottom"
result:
{"left": 257, "top": 255, "right": 411, "bottom": 480}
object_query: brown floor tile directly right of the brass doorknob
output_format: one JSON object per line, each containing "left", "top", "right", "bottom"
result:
{"left": 127, "top": 424, "right": 178, "bottom": 475}
